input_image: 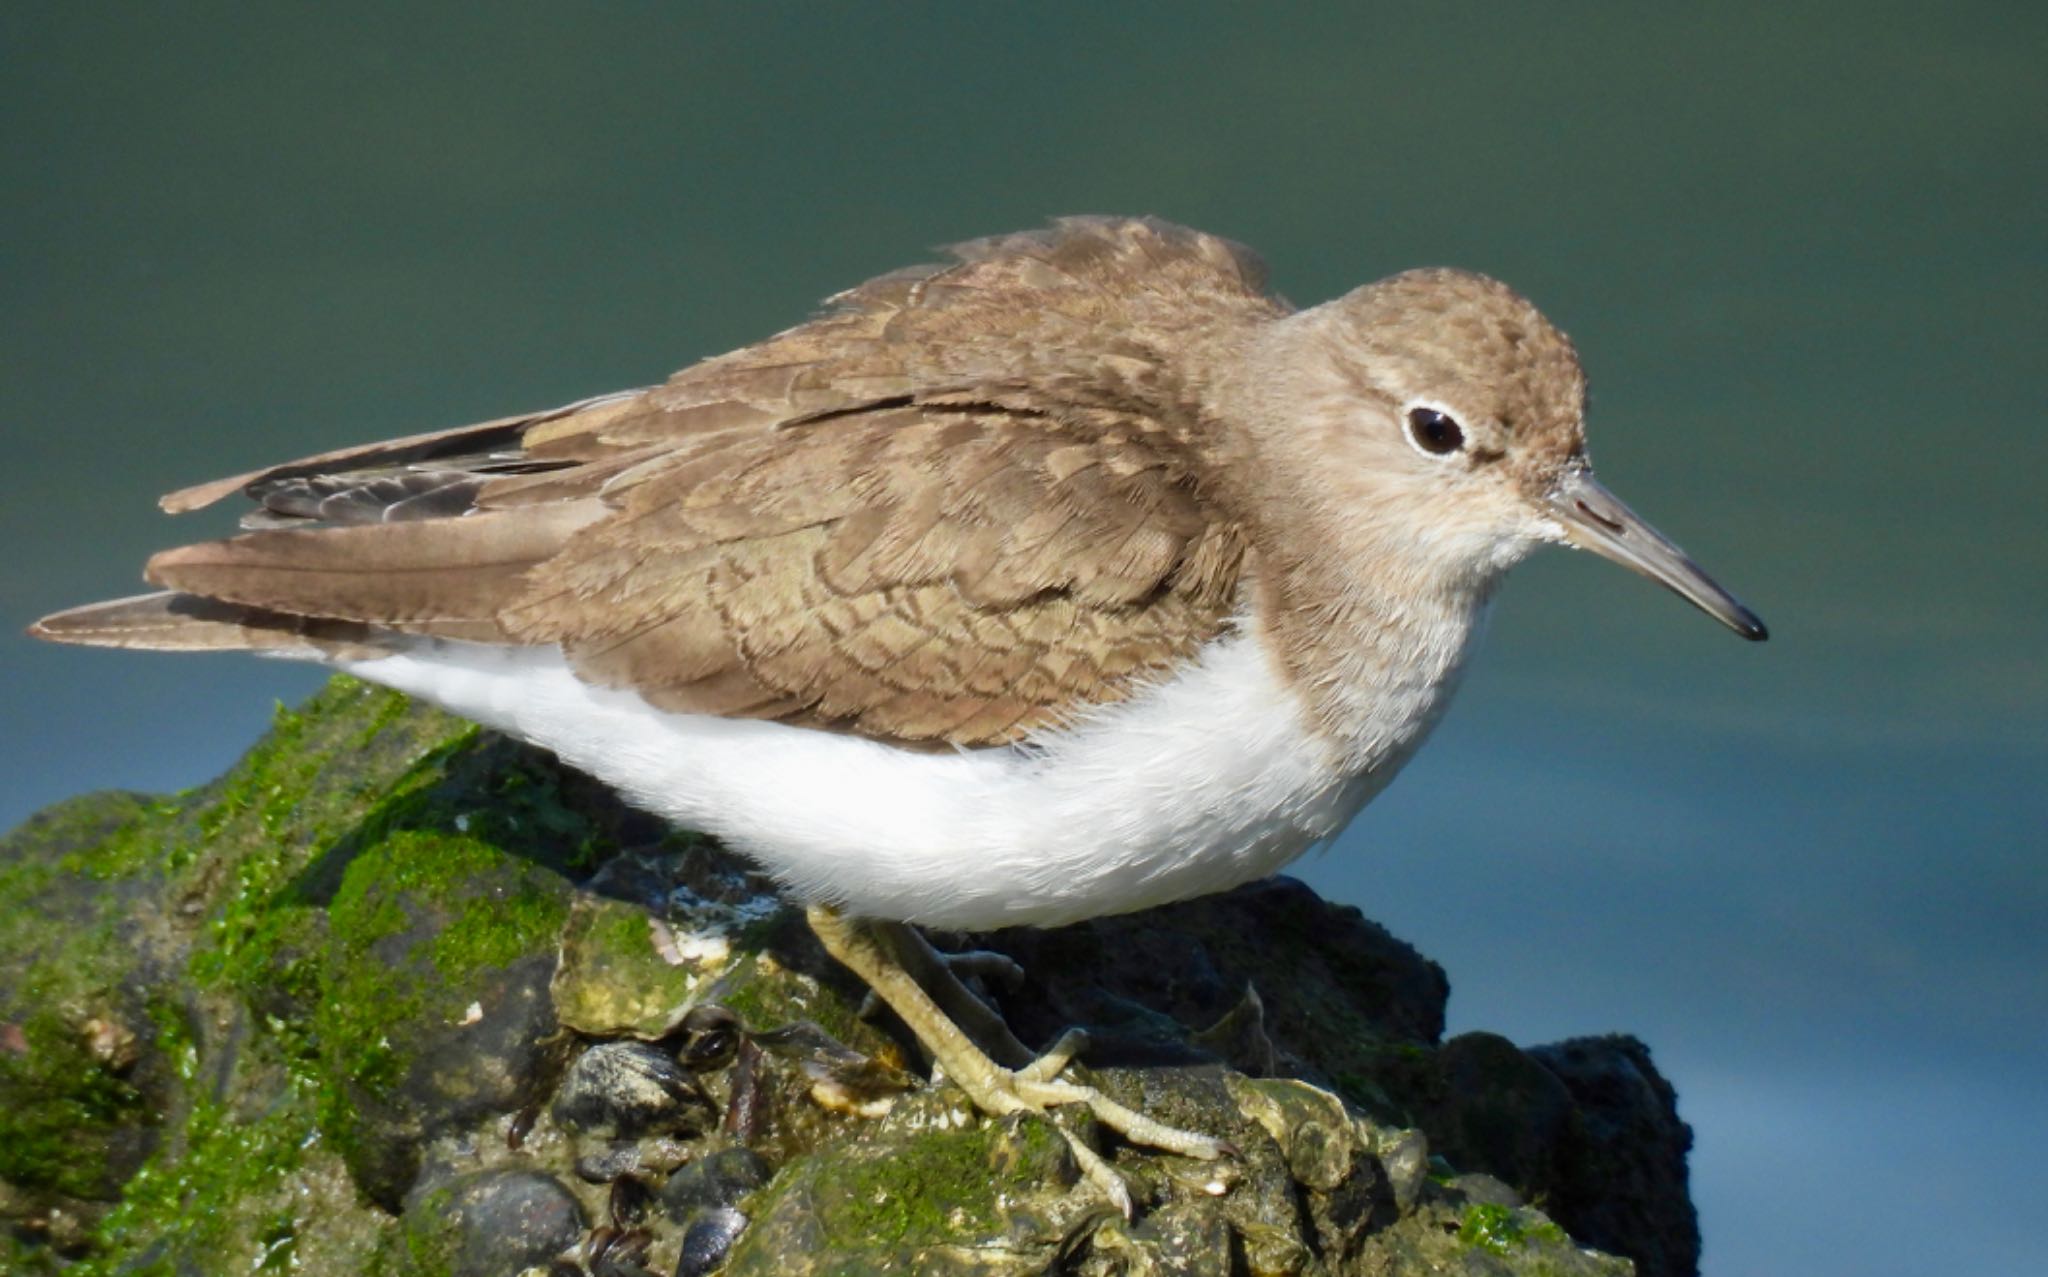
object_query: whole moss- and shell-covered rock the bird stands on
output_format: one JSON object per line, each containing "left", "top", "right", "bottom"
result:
{"left": 0, "top": 679, "right": 1698, "bottom": 1277}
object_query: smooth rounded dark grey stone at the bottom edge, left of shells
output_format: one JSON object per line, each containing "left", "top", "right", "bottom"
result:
{"left": 403, "top": 1171, "right": 586, "bottom": 1277}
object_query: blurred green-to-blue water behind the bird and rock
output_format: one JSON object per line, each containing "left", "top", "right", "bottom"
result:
{"left": 0, "top": 4, "right": 2048, "bottom": 1275}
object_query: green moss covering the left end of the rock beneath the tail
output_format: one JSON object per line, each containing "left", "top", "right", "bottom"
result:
{"left": 0, "top": 677, "right": 623, "bottom": 1273}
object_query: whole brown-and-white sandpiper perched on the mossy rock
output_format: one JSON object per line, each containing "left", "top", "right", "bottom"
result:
{"left": 33, "top": 217, "right": 1763, "bottom": 1209}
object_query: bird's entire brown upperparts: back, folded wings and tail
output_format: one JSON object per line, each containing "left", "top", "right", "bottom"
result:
{"left": 39, "top": 219, "right": 1282, "bottom": 745}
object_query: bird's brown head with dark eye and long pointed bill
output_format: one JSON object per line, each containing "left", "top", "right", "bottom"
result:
{"left": 1235, "top": 270, "right": 1765, "bottom": 639}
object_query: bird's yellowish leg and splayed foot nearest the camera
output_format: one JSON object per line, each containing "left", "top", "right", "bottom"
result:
{"left": 805, "top": 905, "right": 1225, "bottom": 1218}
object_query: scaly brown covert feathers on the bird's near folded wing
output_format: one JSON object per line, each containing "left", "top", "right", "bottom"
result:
{"left": 500, "top": 407, "right": 1241, "bottom": 745}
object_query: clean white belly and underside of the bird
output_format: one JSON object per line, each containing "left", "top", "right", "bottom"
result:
{"left": 342, "top": 634, "right": 1430, "bottom": 931}
